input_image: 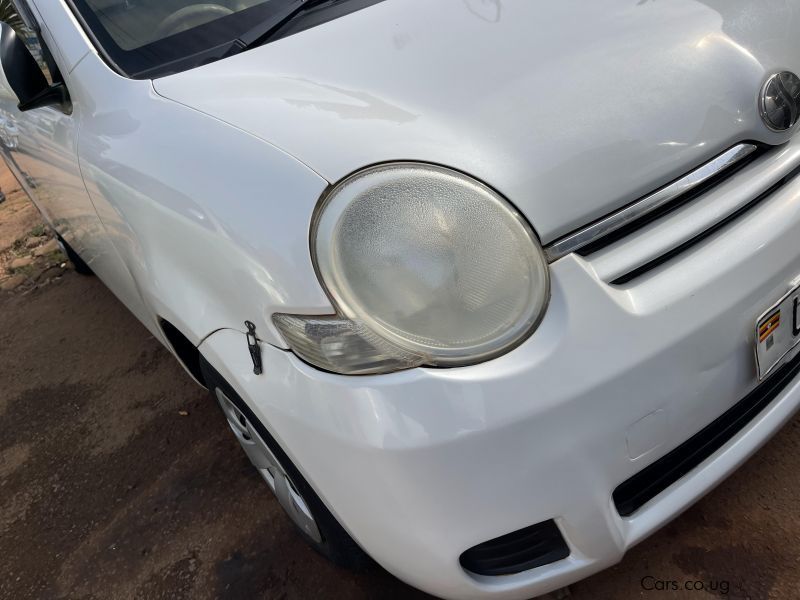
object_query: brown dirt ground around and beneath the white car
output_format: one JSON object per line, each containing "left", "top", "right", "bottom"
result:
{"left": 0, "top": 165, "right": 800, "bottom": 600}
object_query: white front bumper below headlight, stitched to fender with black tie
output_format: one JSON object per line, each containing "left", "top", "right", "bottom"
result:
{"left": 201, "top": 171, "right": 800, "bottom": 598}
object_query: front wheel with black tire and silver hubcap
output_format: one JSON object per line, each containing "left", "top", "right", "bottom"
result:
{"left": 200, "top": 356, "right": 372, "bottom": 571}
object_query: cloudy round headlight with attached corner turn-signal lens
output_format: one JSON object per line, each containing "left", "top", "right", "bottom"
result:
{"left": 273, "top": 163, "right": 550, "bottom": 374}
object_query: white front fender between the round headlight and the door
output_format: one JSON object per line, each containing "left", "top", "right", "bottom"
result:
{"left": 65, "top": 53, "right": 333, "bottom": 345}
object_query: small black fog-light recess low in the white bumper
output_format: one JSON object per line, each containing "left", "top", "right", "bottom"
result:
{"left": 459, "top": 519, "right": 570, "bottom": 576}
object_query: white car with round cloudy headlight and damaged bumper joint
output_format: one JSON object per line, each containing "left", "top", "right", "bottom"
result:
{"left": 0, "top": 0, "right": 800, "bottom": 598}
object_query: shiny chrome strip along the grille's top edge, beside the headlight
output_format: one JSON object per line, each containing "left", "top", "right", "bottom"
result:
{"left": 544, "top": 144, "right": 758, "bottom": 262}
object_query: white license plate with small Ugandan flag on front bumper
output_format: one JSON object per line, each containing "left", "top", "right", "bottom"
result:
{"left": 756, "top": 285, "right": 800, "bottom": 379}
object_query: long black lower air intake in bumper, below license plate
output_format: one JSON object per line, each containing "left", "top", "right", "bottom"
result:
{"left": 613, "top": 355, "right": 800, "bottom": 517}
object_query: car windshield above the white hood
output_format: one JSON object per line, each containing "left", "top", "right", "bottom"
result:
{"left": 66, "top": 0, "right": 380, "bottom": 78}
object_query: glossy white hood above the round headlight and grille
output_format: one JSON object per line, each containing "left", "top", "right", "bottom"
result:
{"left": 154, "top": 0, "right": 800, "bottom": 242}
